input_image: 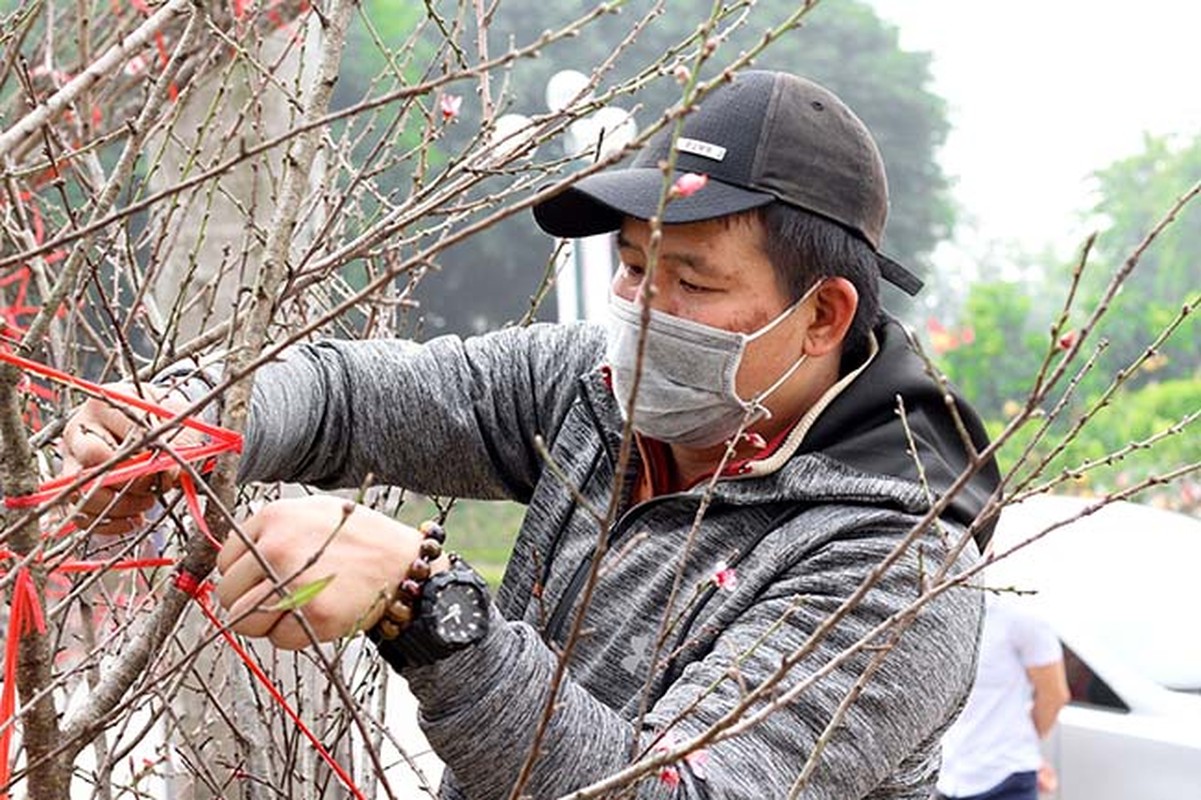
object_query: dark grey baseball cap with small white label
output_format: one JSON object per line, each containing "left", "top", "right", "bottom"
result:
{"left": 533, "top": 70, "right": 921, "bottom": 294}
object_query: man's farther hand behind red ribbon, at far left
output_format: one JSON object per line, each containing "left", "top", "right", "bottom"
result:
{"left": 59, "top": 383, "right": 203, "bottom": 535}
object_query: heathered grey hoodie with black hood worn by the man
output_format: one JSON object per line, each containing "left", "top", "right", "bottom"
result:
{"left": 231, "top": 323, "right": 996, "bottom": 800}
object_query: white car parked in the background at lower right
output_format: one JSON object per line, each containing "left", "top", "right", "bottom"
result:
{"left": 985, "top": 495, "right": 1201, "bottom": 800}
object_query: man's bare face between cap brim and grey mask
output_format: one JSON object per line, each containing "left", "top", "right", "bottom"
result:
{"left": 613, "top": 216, "right": 809, "bottom": 406}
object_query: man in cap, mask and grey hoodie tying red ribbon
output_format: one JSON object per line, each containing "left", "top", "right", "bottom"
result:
{"left": 65, "top": 72, "right": 997, "bottom": 800}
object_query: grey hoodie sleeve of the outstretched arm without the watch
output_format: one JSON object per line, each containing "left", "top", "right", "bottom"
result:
{"left": 239, "top": 326, "right": 602, "bottom": 501}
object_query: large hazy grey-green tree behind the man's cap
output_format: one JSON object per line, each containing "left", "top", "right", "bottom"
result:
{"left": 339, "top": 0, "right": 954, "bottom": 334}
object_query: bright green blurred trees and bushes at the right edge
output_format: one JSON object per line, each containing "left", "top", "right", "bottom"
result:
{"left": 926, "top": 136, "right": 1201, "bottom": 499}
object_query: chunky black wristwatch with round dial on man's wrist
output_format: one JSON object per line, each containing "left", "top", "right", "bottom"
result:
{"left": 369, "top": 556, "right": 489, "bottom": 669}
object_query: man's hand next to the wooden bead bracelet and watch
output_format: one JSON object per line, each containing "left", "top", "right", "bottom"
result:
{"left": 217, "top": 495, "right": 448, "bottom": 650}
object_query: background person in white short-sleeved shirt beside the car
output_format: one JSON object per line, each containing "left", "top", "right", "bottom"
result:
{"left": 938, "top": 595, "right": 1070, "bottom": 800}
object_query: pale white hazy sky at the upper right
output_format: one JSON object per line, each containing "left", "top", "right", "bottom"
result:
{"left": 871, "top": 0, "right": 1201, "bottom": 261}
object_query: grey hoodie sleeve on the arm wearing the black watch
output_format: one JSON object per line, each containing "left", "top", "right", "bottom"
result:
{"left": 404, "top": 516, "right": 980, "bottom": 800}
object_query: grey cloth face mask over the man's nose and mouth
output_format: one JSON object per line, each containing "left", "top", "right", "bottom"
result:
{"left": 607, "top": 281, "right": 821, "bottom": 447}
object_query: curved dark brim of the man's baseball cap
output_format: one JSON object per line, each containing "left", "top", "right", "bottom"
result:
{"left": 533, "top": 167, "right": 775, "bottom": 239}
